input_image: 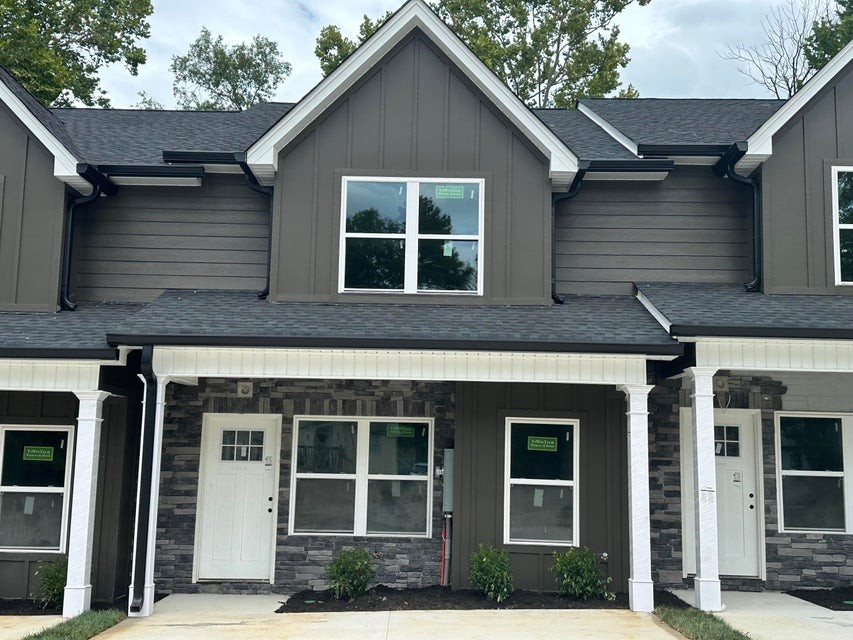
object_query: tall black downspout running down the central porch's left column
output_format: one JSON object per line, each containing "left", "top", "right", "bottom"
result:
{"left": 130, "top": 344, "right": 157, "bottom": 613}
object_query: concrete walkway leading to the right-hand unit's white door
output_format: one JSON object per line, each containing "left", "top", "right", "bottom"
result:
{"left": 674, "top": 591, "right": 853, "bottom": 640}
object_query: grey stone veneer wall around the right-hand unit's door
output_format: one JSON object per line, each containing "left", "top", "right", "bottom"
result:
{"left": 649, "top": 372, "right": 853, "bottom": 590}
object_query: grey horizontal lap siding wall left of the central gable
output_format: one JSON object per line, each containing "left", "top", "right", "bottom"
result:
{"left": 74, "top": 174, "right": 269, "bottom": 301}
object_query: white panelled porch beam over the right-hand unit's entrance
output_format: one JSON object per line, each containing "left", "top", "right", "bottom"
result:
{"left": 696, "top": 338, "right": 853, "bottom": 373}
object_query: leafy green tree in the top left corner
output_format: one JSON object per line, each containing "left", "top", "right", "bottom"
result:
{"left": 0, "top": 0, "right": 153, "bottom": 107}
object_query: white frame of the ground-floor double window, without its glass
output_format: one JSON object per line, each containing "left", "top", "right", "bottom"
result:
{"left": 287, "top": 415, "right": 435, "bottom": 538}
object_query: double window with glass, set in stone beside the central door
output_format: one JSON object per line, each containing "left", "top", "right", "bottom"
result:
{"left": 290, "top": 417, "right": 432, "bottom": 537}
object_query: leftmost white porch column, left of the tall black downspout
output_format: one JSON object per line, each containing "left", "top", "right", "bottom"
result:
{"left": 62, "top": 391, "right": 110, "bottom": 618}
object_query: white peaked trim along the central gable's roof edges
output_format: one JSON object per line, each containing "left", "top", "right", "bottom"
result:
{"left": 246, "top": 0, "right": 578, "bottom": 188}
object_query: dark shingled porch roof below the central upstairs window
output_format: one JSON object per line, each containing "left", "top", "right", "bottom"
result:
{"left": 110, "top": 291, "right": 679, "bottom": 353}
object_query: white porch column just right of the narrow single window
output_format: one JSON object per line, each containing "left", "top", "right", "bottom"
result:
{"left": 619, "top": 384, "right": 655, "bottom": 611}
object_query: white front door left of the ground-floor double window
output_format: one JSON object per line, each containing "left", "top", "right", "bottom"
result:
{"left": 195, "top": 414, "right": 281, "bottom": 580}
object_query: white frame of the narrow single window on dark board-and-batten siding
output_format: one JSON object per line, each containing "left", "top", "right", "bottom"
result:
{"left": 504, "top": 416, "right": 580, "bottom": 547}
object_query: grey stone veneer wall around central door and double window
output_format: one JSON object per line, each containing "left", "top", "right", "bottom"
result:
{"left": 155, "top": 378, "right": 456, "bottom": 593}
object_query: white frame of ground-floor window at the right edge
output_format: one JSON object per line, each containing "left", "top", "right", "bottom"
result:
{"left": 774, "top": 411, "right": 853, "bottom": 535}
